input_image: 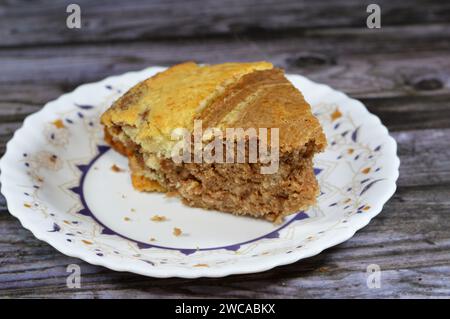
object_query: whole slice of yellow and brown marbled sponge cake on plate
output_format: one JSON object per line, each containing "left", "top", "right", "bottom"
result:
{"left": 101, "top": 62, "right": 326, "bottom": 222}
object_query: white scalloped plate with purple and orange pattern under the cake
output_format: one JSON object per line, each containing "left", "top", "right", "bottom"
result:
{"left": 0, "top": 67, "right": 399, "bottom": 278}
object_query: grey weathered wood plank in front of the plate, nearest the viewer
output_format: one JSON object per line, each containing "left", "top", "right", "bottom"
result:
{"left": 0, "top": 182, "right": 450, "bottom": 298}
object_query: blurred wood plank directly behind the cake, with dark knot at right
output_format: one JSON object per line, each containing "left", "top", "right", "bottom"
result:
{"left": 0, "top": 28, "right": 450, "bottom": 98}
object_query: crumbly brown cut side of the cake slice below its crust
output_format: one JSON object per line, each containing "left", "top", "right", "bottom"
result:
{"left": 107, "top": 130, "right": 319, "bottom": 222}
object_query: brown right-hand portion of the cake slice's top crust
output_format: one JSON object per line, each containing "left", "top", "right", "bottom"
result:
{"left": 197, "top": 68, "right": 326, "bottom": 152}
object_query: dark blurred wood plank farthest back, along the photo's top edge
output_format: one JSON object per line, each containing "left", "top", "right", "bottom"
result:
{"left": 0, "top": 0, "right": 450, "bottom": 47}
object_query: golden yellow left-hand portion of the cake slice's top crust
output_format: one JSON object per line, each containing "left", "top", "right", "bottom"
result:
{"left": 101, "top": 62, "right": 273, "bottom": 157}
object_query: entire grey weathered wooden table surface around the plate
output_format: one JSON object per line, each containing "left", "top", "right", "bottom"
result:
{"left": 0, "top": 0, "right": 450, "bottom": 298}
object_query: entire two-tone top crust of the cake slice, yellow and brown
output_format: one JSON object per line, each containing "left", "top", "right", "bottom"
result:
{"left": 102, "top": 62, "right": 325, "bottom": 157}
